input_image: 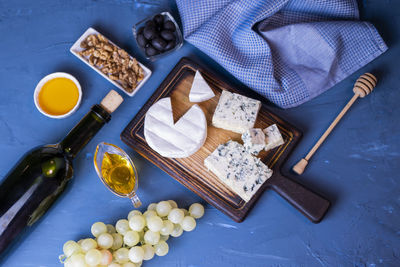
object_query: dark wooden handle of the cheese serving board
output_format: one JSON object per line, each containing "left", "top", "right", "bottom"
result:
{"left": 270, "top": 174, "right": 330, "bottom": 223}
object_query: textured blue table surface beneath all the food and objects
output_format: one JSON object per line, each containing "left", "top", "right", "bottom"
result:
{"left": 0, "top": 0, "right": 400, "bottom": 267}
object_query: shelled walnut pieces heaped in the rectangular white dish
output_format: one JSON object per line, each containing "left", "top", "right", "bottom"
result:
{"left": 78, "top": 34, "right": 144, "bottom": 93}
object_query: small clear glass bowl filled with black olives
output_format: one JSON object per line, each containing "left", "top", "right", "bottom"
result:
{"left": 133, "top": 12, "right": 183, "bottom": 61}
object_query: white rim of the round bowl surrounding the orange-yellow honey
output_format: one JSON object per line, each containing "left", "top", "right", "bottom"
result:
{"left": 33, "top": 72, "right": 82, "bottom": 119}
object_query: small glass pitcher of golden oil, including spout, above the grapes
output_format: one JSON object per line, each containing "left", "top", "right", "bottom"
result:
{"left": 94, "top": 142, "right": 142, "bottom": 208}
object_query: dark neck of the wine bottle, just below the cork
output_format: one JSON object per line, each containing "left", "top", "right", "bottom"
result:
{"left": 59, "top": 105, "right": 111, "bottom": 158}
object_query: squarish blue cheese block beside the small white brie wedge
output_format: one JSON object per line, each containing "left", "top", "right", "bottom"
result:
{"left": 212, "top": 90, "right": 261, "bottom": 134}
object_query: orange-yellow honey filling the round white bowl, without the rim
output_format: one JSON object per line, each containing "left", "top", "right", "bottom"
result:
{"left": 38, "top": 78, "right": 79, "bottom": 116}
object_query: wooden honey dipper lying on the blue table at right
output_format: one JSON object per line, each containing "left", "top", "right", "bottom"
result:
{"left": 293, "top": 73, "right": 378, "bottom": 174}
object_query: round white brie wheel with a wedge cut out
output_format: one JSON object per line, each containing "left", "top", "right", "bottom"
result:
{"left": 144, "top": 97, "right": 207, "bottom": 158}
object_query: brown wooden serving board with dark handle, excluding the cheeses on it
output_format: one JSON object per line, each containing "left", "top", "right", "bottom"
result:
{"left": 121, "top": 58, "right": 329, "bottom": 222}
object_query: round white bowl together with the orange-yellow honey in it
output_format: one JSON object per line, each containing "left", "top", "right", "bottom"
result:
{"left": 33, "top": 72, "right": 82, "bottom": 119}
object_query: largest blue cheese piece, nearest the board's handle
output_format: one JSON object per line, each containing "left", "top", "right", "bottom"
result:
{"left": 204, "top": 141, "right": 272, "bottom": 202}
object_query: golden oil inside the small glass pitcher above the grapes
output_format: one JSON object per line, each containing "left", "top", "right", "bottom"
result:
{"left": 101, "top": 152, "right": 135, "bottom": 195}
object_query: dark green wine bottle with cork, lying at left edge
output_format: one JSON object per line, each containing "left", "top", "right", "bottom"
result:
{"left": 0, "top": 90, "right": 123, "bottom": 255}
